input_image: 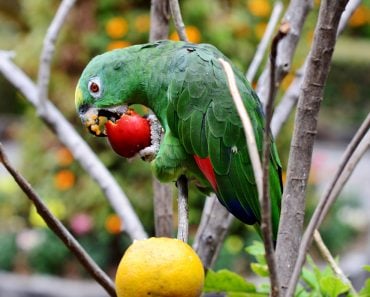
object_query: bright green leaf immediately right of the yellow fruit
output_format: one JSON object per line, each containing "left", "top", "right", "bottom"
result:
{"left": 204, "top": 269, "right": 256, "bottom": 293}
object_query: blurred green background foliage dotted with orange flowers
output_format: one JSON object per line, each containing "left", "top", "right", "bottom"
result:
{"left": 0, "top": 0, "right": 370, "bottom": 274}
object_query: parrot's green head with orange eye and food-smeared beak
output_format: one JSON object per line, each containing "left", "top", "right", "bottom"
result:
{"left": 75, "top": 49, "right": 143, "bottom": 136}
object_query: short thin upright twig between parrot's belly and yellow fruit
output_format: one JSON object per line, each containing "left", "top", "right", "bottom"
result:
{"left": 176, "top": 175, "right": 189, "bottom": 242}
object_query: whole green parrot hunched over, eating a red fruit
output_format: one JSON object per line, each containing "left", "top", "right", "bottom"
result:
{"left": 75, "top": 40, "right": 282, "bottom": 239}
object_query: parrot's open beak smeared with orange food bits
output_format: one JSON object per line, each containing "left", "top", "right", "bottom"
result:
{"left": 79, "top": 105, "right": 128, "bottom": 137}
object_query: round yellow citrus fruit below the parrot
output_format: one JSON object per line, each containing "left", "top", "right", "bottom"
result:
{"left": 116, "top": 237, "right": 204, "bottom": 297}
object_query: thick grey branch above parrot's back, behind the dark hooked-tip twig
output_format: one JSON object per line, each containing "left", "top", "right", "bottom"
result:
{"left": 257, "top": 0, "right": 313, "bottom": 104}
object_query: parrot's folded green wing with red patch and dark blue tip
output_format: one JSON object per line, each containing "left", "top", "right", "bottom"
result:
{"left": 167, "top": 44, "right": 282, "bottom": 235}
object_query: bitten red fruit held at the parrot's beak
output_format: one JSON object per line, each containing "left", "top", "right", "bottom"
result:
{"left": 105, "top": 110, "right": 151, "bottom": 158}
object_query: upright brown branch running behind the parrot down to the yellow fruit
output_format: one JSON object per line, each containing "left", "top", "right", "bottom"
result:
{"left": 149, "top": 0, "right": 173, "bottom": 237}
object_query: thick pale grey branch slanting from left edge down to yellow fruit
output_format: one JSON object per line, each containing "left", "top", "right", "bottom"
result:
{"left": 0, "top": 51, "right": 147, "bottom": 239}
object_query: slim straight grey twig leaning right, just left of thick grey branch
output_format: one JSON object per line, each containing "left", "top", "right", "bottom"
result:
{"left": 246, "top": 1, "right": 284, "bottom": 82}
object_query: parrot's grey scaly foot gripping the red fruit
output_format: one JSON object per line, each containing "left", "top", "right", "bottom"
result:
{"left": 138, "top": 114, "right": 164, "bottom": 162}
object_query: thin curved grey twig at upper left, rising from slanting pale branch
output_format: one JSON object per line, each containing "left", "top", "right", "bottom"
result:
{"left": 37, "top": 0, "right": 76, "bottom": 113}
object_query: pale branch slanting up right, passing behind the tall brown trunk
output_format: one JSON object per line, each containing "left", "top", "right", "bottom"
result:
{"left": 271, "top": 0, "right": 361, "bottom": 137}
